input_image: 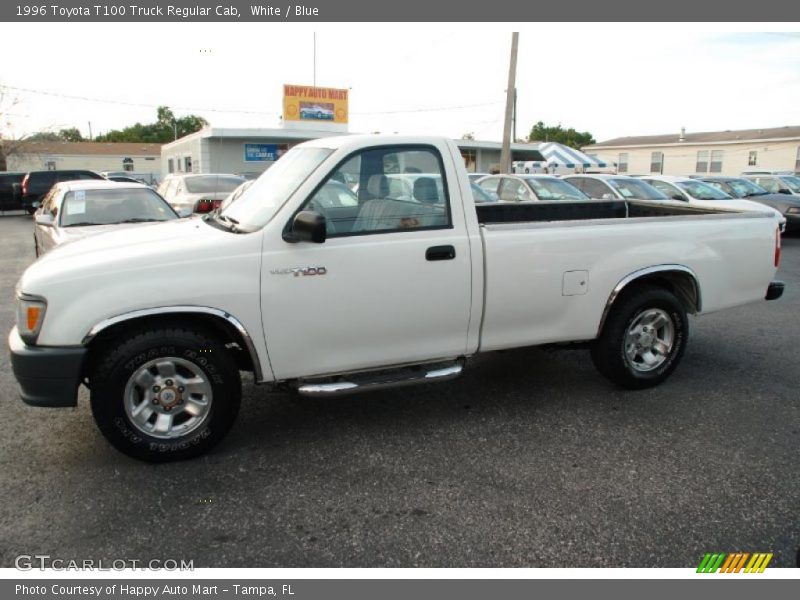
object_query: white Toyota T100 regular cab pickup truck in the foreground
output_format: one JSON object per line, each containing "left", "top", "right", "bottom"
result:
{"left": 9, "top": 136, "right": 783, "bottom": 461}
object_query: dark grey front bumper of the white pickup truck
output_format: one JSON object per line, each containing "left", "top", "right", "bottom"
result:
{"left": 8, "top": 327, "right": 88, "bottom": 406}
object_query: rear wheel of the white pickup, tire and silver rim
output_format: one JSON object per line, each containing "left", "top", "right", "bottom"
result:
{"left": 591, "top": 285, "right": 689, "bottom": 389}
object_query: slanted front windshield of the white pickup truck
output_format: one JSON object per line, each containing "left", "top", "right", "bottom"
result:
{"left": 221, "top": 147, "right": 333, "bottom": 229}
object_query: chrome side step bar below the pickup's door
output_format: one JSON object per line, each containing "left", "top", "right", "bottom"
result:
{"left": 297, "top": 359, "right": 464, "bottom": 398}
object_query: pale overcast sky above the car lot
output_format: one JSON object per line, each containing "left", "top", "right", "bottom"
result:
{"left": 0, "top": 23, "right": 800, "bottom": 140}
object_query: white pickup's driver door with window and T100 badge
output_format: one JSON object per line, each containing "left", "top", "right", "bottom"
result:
{"left": 261, "top": 145, "right": 472, "bottom": 379}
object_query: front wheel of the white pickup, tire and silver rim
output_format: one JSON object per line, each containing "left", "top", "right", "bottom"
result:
{"left": 89, "top": 328, "right": 241, "bottom": 462}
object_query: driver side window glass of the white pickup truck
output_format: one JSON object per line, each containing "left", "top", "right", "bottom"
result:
{"left": 302, "top": 147, "right": 452, "bottom": 237}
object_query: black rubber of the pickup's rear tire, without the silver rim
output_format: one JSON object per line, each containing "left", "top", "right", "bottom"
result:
{"left": 591, "top": 285, "right": 689, "bottom": 389}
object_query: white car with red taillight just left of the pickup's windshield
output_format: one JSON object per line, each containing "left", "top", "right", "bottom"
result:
{"left": 158, "top": 173, "right": 247, "bottom": 214}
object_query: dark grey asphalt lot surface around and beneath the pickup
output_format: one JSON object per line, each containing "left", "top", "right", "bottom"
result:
{"left": 0, "top": 216, "right": 800, "bottom": 567}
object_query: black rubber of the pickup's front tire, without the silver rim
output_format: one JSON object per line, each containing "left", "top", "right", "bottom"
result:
{"left": 89, "top": 326, "right": 241, "bottom": 462}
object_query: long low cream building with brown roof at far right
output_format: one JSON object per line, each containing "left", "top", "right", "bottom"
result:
{"left": 582, "top": 126, "right": 800, "bottom": 175}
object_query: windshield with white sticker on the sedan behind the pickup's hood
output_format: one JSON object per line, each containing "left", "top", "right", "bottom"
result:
{"left": 61, "top": 187, "right": 178, "bottom": 227}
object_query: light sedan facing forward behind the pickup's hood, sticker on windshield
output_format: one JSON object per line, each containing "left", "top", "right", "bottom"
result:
{"left": 33, "top": 181, "right": 178, "bottom": 256}
